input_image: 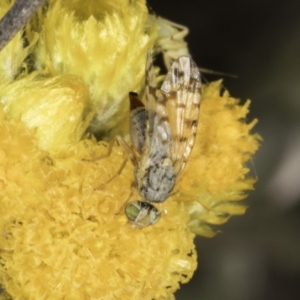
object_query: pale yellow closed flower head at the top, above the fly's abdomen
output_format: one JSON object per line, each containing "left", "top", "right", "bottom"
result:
{"left": 35, "top": 0, "right": 156, "bottom": 139}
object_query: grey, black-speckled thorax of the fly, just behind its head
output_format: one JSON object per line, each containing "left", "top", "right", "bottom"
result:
{"left": 139, "top": 158, "right": 176, "bottom": 202}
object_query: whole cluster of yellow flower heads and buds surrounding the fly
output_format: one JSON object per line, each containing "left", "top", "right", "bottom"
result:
{"left": 0, "top": 0, "right": 259, "bottom": 300}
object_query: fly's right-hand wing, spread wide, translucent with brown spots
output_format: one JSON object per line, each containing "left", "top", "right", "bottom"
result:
{"left": 158, "top": 56, "right": 201, "bottom": 175}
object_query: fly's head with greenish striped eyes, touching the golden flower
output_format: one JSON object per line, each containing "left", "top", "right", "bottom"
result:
{"left": 125, "top": 200, "right": 161, "bottom": 227}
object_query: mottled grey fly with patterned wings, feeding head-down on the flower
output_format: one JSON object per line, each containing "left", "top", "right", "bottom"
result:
{"left": 125, "top": 51, "right": 201, "bottom": 227}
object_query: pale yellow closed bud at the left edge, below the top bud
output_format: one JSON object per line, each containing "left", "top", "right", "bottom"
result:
{"left": 0, "top": 74, "right": 92, "bottom": 152}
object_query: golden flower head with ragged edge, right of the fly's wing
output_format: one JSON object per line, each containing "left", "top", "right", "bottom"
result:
{"left": 175, "top": 81, "right": 261, "bottom": 237}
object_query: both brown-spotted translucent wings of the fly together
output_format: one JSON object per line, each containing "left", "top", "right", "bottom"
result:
{"left": 146, "top": 51, "right": 201, "bottom": 175}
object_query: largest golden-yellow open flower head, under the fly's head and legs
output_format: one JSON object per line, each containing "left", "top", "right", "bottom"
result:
{"left": 0, "top": 106, "right": 196, "bottom": 299}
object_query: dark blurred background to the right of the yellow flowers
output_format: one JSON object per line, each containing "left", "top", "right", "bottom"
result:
{"left": 148, "top": 0, "right": 300, "bottom": 300}
